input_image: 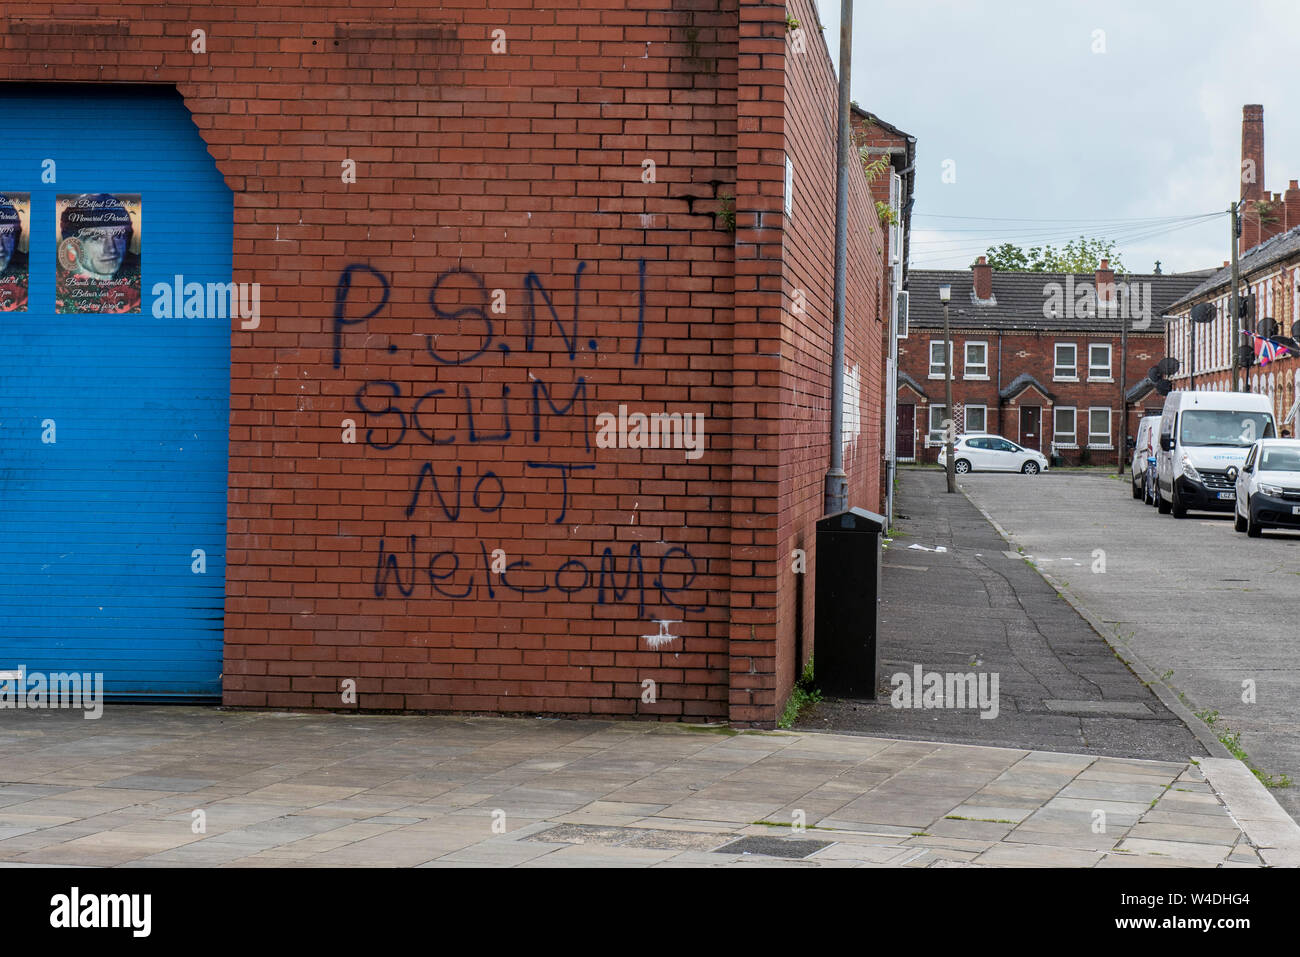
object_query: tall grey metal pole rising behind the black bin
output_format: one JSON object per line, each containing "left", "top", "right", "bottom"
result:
{"left": 823, "top": 0, "right": 857, "bottom": 515}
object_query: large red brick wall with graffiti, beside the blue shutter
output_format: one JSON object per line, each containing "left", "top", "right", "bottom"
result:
{"left": 0, "top": 0, "right": 879, "bottom": 724}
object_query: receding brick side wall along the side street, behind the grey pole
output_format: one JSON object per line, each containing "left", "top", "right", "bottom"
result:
{"left": 776, "top": 0, "right": 888, "bottom": 703}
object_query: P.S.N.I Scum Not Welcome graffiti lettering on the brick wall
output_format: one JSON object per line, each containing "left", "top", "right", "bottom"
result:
{"left": 333, "top": 260, "right": 703, "bottom": 621}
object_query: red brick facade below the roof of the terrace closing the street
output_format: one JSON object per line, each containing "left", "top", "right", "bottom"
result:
{"left": 898, "top": 326, "right": 1165, "bottom": 464}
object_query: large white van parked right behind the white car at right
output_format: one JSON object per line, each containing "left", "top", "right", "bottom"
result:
{"left": 1156, "top": 391, "right": 1278, "bottom": 519}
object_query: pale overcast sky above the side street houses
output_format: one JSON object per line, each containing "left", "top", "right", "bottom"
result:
{"left": 816, "top": 0, "right": 1300, "bottom": 272}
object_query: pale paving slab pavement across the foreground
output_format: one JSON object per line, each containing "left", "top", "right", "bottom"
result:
{"left": 0, "top": 705, "right": 1300, "bottom": 867}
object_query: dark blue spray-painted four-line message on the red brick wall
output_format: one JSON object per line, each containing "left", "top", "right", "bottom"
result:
{"left": 333, "top": 260, "right": 703, "bottom": 616}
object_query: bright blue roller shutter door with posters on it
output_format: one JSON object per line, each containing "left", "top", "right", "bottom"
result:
{"left": 0, "top": 85, "right": 233, "bottom": 698}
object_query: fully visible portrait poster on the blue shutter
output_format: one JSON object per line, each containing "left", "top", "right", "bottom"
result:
{"left": 55, "top": 192, "right": 140, "bottom": 313}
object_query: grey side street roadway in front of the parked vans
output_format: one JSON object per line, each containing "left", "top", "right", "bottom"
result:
{"left": 956, "top": 472, "right": 1300, "bottom": 820}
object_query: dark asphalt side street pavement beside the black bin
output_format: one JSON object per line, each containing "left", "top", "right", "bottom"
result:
{"left": 798, "top": 468, "right": 1211, "bottom": 762}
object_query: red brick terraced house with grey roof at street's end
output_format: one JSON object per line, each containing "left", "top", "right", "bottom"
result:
{"left": 897, "top": 256, "right": 1208, "bottom": 464}
